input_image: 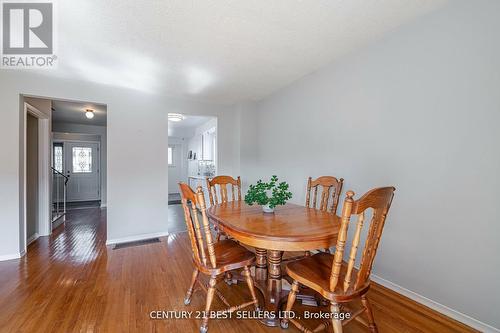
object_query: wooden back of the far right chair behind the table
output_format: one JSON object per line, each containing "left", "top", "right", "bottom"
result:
{"left": 306, "top": 176, "right": 344, "bottom": 214}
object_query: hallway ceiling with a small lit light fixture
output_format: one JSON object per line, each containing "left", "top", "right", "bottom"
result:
{"left": 52, "top": 101, "right": 107, "bottom": 126}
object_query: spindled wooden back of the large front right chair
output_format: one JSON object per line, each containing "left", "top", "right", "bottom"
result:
{"left": 330, "top": 187, "right": 396, "bottom": 293}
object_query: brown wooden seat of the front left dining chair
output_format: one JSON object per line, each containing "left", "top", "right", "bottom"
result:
{"left": 198, "top": 239, "right": 255, "bottom": 275}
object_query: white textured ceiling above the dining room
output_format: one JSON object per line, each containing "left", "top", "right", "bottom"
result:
{"left": 46, "top": 0, "right": 447, "bottom": 104}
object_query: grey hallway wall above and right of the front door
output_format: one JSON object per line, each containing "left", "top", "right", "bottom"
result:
{"left": 52, "top": 123, "right": 108, "bottom": 206}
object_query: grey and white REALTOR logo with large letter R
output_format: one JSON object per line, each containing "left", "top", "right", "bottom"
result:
{"left": 2, "top": 2, "right": 57, "bottom": 69}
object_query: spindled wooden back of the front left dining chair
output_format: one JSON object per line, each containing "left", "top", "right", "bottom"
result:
{"left": 179, "top": 183, "right": 217, "bottom": 268}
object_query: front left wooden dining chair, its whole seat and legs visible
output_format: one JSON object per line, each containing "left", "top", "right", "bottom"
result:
{"left": 179, "top": 183, "right": 259, "bottom": 332}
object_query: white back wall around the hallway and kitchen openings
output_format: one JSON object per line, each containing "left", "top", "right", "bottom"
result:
{"left": 0, "top": 69, "right": 239, "bottom": 252}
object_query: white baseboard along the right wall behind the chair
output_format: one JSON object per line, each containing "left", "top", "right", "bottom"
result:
{"left": 370, "top": 274, "right": 500, "bottom": 333}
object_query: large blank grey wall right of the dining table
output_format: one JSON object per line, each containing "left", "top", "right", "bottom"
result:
{"left": 250, "top": 1, "right": 500, "bottom": 330}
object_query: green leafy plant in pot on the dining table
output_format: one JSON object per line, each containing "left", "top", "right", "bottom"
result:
{"left": 245, "top": 175, "right": 292, "bottom": 213}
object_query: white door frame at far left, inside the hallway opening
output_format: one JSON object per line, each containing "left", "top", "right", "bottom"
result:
{"left": 19, "top": 102, "right": 52, "bottom": 256}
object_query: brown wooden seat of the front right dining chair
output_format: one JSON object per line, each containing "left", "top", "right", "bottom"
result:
{"left": 286, "top": 252, "right": 369, "bottom": 302}
